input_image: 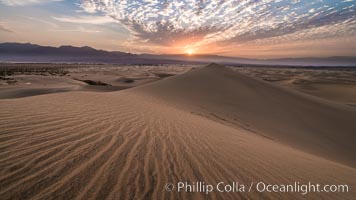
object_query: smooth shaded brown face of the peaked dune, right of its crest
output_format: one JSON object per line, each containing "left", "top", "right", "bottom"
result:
{"left": 135, "top": 64, "right": 356, "bottom": 166}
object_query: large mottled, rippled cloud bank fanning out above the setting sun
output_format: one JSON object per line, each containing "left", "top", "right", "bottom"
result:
{"left": 80, "top": 0, "right": 356, "bottom": 50}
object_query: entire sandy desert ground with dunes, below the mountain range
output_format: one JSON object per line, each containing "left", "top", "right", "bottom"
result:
{"left": 0, "top": 64, "right": 356, "bottom": 199}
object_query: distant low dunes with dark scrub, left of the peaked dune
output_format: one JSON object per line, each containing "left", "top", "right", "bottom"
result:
{"left": 0, "top": 63, "right": 192, "bottom": 99}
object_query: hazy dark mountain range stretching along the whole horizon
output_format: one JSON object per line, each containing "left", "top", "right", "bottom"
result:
{"left": 0, "top": 43, "right": 356, "bottom": 66}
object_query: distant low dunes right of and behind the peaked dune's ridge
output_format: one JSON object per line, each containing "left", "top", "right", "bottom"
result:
{"left": 231, "top": 67, "right": 356, "bottom": 106}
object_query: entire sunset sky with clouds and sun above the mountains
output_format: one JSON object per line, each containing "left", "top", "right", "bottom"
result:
{"left": 0, "top": 0, "right": 356, "bottom": 58}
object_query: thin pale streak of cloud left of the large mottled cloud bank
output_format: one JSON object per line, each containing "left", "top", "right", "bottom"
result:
{"left": 53, "top": 16, "right": 116, "bottom": 24}
